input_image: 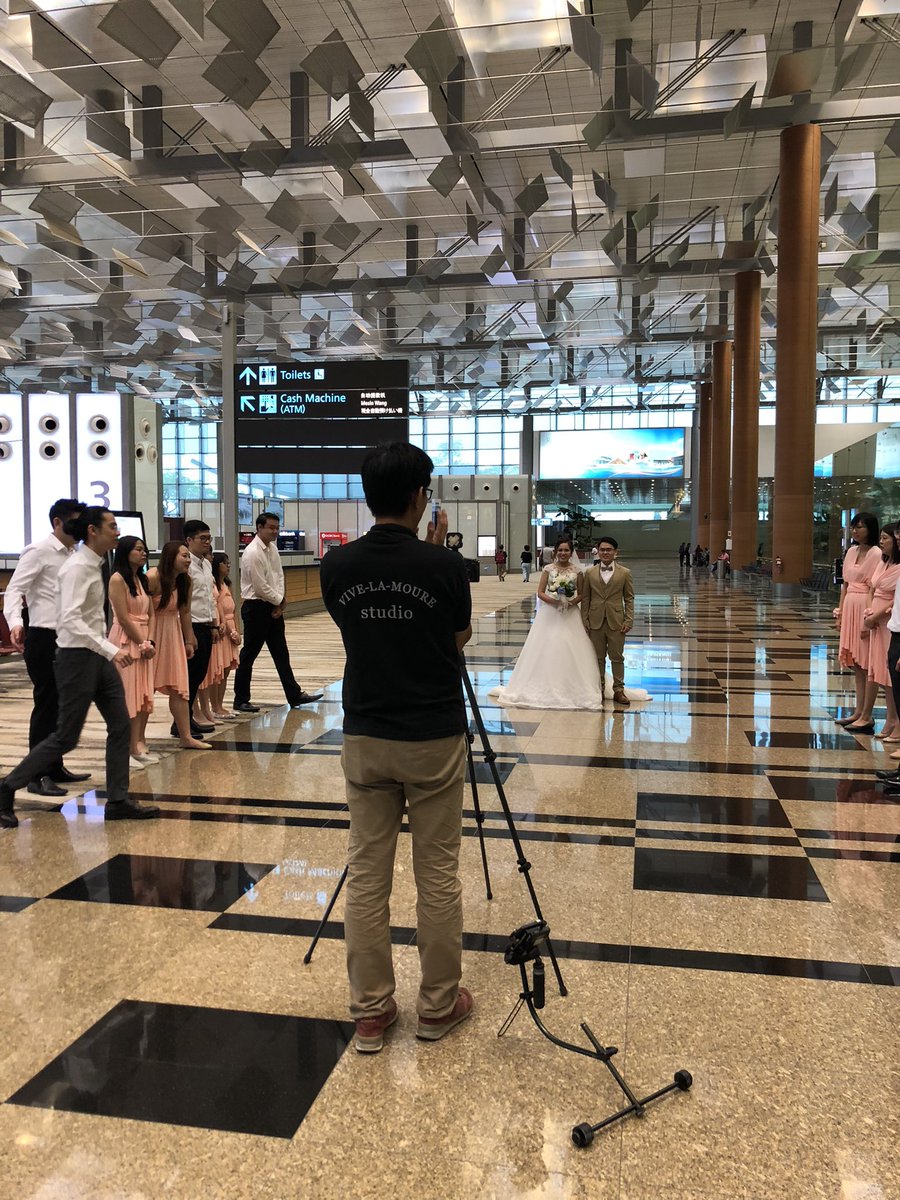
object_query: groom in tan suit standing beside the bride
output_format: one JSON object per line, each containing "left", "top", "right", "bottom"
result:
{"left": 581, "top": 538, "right": 635, "bottom": 706}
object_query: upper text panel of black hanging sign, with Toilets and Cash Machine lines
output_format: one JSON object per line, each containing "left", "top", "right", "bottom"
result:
{"left": 234, "top": 359, "right": 409, "bottom": 420}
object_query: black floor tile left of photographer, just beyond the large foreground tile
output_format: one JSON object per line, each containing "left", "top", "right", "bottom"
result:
{"left": 48, "top": 854, "right": 275, "bottom": 912}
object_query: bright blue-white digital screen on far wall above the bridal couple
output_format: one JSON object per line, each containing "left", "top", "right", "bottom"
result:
{"left": 538, "top": 430, "right": 684, "bottom": 479}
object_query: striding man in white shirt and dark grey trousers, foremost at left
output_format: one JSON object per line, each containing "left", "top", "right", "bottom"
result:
{"left": 0, "top": 505, "right": 160, "bottom": 829}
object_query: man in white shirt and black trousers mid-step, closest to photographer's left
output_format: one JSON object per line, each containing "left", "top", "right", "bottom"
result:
{"left": 234, "top": 512, "right": 324, "bottom": 713}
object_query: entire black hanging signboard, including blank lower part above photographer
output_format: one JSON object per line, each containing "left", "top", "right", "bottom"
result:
{"left": 234, "top": 359, "right": 409, "bottom": 474}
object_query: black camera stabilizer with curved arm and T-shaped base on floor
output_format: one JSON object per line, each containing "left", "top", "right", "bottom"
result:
{"left": 497, "top": 920, "right": 694, "bottom": 1148}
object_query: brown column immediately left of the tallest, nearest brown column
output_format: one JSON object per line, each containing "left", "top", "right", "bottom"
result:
{"left": 731, "top": 271, "right": 761, "bottom": 570}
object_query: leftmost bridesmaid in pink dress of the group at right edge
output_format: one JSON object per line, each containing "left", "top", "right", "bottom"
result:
{"left": 834, "top": 512, "right": 881, "bottom": 733}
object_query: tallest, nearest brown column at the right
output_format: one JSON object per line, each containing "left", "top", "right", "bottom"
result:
{"left": 772, "top": 125, "right": 822, "bottom": 595}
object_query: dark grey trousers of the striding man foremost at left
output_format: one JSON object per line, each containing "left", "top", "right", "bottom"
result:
{"left": 4, "top": 649, "right": 131, "bottom": 804}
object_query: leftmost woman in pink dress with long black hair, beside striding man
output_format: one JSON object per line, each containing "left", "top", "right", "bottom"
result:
{"left": 109, "top": 536, "right": 160, "bottom": 770}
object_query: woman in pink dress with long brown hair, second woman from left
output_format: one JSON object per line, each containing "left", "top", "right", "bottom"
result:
{"left": 146, "top": 541, "right": 212, "bottom": 750}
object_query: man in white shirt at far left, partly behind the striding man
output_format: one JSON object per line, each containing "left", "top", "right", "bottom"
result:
{"left": 4, "top": 499, "right": 91, "bottom": 796}
